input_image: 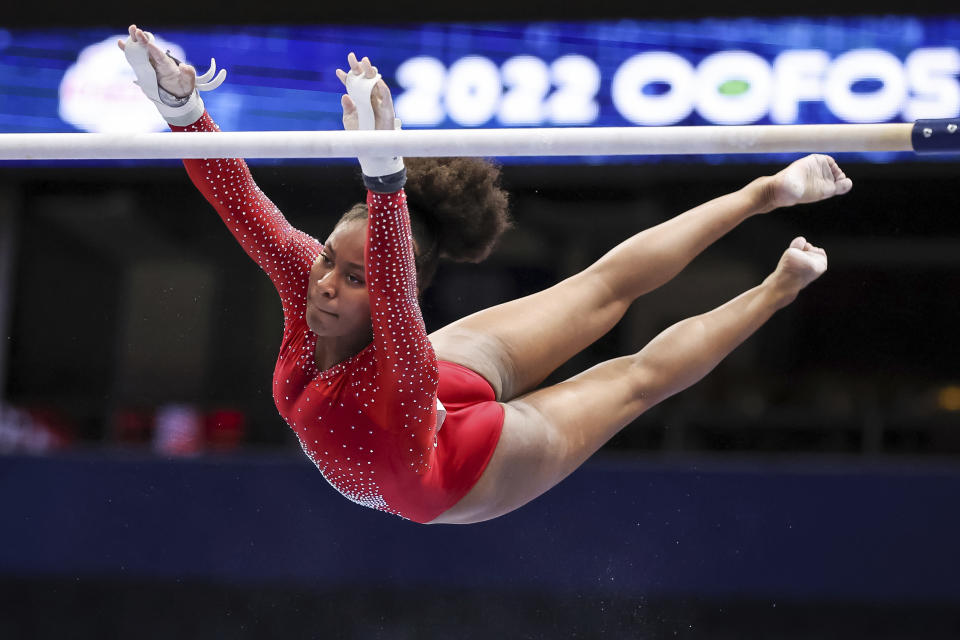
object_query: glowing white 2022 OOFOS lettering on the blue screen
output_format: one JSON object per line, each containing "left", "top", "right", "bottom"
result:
{"left": 395, "top": 47, "right": 960, "bottom": 127}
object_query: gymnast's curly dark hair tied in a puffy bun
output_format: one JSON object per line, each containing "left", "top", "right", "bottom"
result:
{"left": 337, "top": 158, "right": 511, "bottom": 293}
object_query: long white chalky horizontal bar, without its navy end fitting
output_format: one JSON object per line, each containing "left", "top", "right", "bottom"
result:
{"left": 0, "top": 123, "right": 913, "bottom": 160}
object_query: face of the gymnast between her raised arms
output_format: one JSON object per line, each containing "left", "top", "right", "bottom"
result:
{"left": 307, "top": 220, "right": 371, "bottom": 341}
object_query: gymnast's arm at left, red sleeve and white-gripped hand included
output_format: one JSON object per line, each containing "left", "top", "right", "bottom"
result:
{"left": 118, "top": 25, "right": 322, "bottom": 319}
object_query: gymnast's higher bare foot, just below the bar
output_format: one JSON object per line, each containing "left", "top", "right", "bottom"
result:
{"left": 764, "top": 154, "right": 853, "bottom": 211}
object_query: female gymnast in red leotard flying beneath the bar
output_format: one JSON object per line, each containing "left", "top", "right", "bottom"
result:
{"left": 118, "top": 25, "right": 852, "bottom": 524}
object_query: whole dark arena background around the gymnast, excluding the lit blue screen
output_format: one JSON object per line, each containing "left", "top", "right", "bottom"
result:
{"left": 0, "top": 0, "right": 960, "bottom": 638}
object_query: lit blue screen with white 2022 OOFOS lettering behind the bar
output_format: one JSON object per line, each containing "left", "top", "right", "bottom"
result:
{"left": 0, "top": 16, "right": 960, "bottom": 162}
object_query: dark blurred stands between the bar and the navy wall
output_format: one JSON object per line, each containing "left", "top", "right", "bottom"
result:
{"left": 2, "top": 160, "right": 960, "bottom": 455}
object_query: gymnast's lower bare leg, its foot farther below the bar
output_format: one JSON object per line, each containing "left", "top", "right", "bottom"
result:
{"left": 434, "top": 238, "right": 827, "bottom": 524}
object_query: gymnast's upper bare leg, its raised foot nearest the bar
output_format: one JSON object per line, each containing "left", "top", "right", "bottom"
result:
{"left": 430, "top": 155, "right": 852, "bottom": 402}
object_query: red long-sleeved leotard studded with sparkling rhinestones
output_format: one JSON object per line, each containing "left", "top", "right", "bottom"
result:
{"left": 171, "top": 112, "right": 503, "bottom": 522}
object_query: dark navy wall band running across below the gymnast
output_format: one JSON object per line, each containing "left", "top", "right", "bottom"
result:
{"left": 0, "top": 455, "right": 960, "bottom": 604}
